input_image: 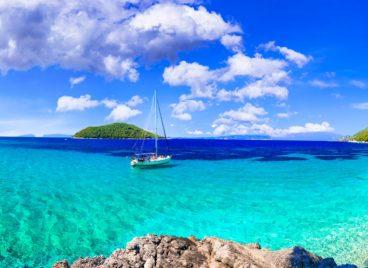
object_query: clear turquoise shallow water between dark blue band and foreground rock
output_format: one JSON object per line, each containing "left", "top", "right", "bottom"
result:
{"left": 0, "top": 140, "right": 368, "bottom": 267}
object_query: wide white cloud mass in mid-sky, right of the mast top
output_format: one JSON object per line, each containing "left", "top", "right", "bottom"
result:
{"left": 163, "top": 52, "right": 290, "bottom": 104}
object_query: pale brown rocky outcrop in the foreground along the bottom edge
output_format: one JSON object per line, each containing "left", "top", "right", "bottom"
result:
{"left": 53, "top": 235, "right": 356, "bottom": 268}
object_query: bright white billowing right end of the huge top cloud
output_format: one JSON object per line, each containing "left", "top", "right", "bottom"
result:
{"left": 129, "top": 3, "right": 241, "bottom": 44}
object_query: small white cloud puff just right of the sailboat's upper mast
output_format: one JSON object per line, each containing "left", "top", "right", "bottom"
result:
{"left": 170, "top": 99, "right": 206, "bottom": 121}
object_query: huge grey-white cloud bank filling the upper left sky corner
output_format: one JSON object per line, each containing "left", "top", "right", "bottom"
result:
{"left": 0, "top": 0, "right": 241, "bottom": 81}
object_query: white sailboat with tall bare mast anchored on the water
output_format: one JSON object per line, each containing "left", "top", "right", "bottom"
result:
{"left": 130, "top": 90, "right": 171, "bottom": 167}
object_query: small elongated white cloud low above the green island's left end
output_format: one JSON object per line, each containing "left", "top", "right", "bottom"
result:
{"left": 56, "top": 95, "right": 100, "bottom": 112}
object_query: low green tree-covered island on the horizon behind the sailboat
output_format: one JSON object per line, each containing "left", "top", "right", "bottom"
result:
{"left": 73, "top": 123, "right": 155, "bottom": 139}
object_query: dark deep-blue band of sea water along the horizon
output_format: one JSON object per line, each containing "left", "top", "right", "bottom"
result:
{"left": 5, "top": 138, "right": 368, "bottom": 161}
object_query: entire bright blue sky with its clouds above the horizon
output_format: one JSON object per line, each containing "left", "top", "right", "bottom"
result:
{"left": 0, "top": 0, "right": 368, "bottom": 138}
